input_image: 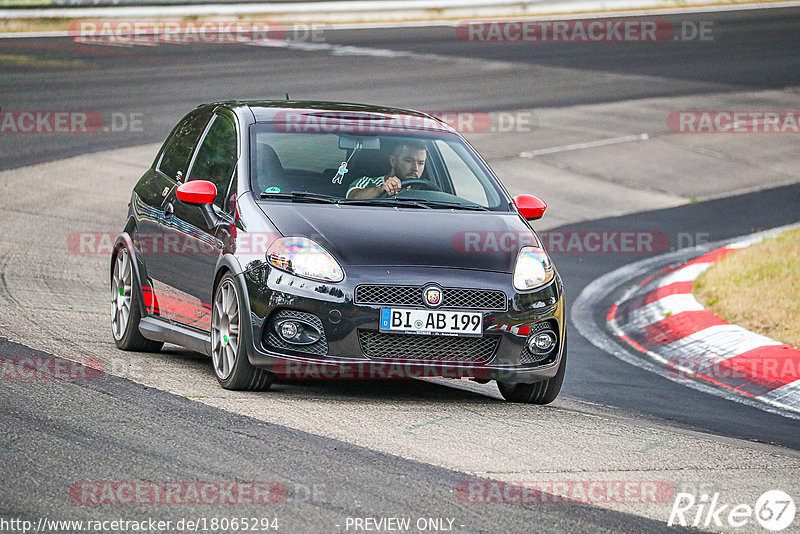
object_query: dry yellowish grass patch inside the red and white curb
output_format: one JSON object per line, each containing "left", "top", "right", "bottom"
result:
{"left": 692, "top": 230, "right": 800, "bottom": 348}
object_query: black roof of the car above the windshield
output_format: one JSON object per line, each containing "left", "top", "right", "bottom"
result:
{"left": 206, "top": 100, "right": 455, "bottom": 133}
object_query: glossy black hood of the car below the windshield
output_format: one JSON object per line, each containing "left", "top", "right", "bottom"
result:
{"left": 259, "top": 201, "right": 539, "bottom": 273}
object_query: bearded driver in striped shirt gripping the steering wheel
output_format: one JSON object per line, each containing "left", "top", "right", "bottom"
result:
{"left": 347, "top": 141, "right": 428, "bottom": 198}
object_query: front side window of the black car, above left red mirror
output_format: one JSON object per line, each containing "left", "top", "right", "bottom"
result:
{"left": 189, "top": 115, "right": 236, "bottom": 209}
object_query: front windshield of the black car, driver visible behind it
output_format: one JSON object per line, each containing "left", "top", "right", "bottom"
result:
{"left": 250, "top": 124, "right": 509, "bottom": 211}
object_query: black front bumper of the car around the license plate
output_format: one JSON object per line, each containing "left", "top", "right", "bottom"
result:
{"left": 242, "top": 264, "right": 565, "bottom": 383}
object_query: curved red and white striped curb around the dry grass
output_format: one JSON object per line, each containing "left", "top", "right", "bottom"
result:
{"left": 573, "top": 225, "right": 800, "bottom": 417}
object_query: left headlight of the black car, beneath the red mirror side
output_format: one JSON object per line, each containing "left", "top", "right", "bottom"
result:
{"left": 267, "top": 237, "right": 344, "bottom": 282}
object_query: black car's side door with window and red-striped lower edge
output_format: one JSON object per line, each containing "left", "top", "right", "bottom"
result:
{"left": 154, "top": 114, "right": 238, "bottom": 330}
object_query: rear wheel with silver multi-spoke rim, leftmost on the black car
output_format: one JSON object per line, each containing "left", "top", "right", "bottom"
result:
{"left": 111, "top": 245, "right": 164, "bottom": 352}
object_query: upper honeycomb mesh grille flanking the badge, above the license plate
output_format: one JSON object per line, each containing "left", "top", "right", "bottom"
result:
{"left": 355, "top": 285, "right": 506, "bottom": 311}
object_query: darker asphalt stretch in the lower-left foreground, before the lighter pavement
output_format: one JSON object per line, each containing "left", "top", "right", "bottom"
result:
{"left": 0, "top": 341, "right": 700, "bottom": 533}
